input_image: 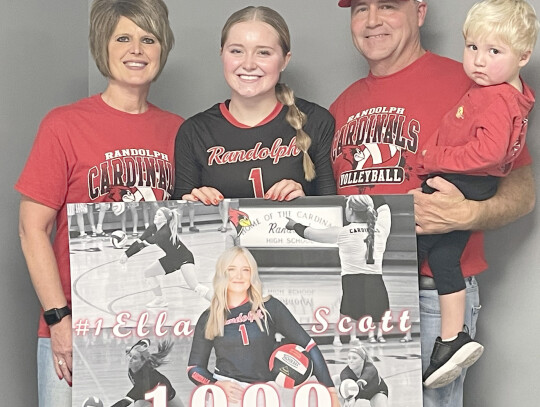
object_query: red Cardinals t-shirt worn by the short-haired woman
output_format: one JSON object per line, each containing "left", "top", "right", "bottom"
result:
{"left": 15, "top": 95, "right": 184, "bottom": 337}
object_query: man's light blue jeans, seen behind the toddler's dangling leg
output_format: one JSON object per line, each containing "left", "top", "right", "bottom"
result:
{"left": 420, "top": 277, "right": 480, "bottom": 407}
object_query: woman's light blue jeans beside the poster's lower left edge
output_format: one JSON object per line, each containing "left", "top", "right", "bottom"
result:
{"left": 37, "top": 338, "right": 71, "bottom": 407}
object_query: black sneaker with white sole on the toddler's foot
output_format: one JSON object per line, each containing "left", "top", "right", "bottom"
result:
{"left": 422, "top": 332, "right": 484, "bottom": 389}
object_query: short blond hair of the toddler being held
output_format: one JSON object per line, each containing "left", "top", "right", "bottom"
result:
{"left": 463, "top": 0, "right": 540, "bottom": 55}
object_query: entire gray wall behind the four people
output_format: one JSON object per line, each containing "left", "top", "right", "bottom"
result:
{"left": 0, "top": 0, "right": 540, "bottom": 407}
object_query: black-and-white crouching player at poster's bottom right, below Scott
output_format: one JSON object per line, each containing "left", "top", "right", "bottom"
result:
{"left": 335, "top": 346, "right": 388, "bottom": 407}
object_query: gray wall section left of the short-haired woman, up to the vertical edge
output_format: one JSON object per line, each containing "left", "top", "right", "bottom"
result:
{"left": 0, "top": 0, "right": 88, "bottom": 406}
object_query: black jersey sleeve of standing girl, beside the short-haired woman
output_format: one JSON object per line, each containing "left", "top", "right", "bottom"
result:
{"left": 172, "top": 119, "right": 201, "bottom": 199}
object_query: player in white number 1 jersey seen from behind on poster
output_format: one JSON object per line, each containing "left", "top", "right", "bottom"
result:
{"left": 286, "top": 195, "right": 392, "bottom": 346}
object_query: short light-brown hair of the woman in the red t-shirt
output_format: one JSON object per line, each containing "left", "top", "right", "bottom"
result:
{"left": 89, "top": 0, "right": 174, "bottom": 80}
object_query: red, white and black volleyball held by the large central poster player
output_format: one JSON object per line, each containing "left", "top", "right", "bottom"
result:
{"left": 268, "top": 343, "right": 313, "bottom": 389}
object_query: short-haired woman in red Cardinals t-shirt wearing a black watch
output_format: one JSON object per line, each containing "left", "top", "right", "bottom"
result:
{"left": 15, "top": 0, "right": 178, "bottom": 407}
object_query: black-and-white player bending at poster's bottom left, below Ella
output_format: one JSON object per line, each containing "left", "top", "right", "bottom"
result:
{"left": 112, "top": 339, "right": 183, "bottom": 407}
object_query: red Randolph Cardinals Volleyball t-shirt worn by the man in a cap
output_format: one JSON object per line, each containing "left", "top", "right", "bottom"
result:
{"left": 330, "top": 52, "right": 531, "bottom": 276}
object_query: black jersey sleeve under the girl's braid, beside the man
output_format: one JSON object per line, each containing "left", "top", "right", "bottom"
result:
{"left": 306, "top": 106, "right": 337, "bottom": 195}
